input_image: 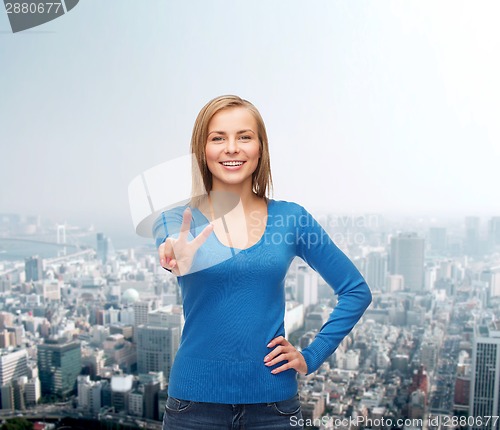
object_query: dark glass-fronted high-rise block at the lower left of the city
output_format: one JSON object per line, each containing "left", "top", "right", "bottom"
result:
{"left": 38, "top": 339, "right": 82, "bottom": 397}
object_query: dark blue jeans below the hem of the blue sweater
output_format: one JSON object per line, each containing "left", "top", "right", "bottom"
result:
{"left": 163, "top": 393, "right": 303, "bottom": 430}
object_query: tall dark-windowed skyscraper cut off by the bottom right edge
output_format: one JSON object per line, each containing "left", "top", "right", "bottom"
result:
{"left": 469, "top": 322, "right": 500, "bottom": 429}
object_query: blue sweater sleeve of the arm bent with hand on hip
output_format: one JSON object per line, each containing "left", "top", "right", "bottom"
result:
{"left": 297, "top": 207, "right": 372, "bottom": 375}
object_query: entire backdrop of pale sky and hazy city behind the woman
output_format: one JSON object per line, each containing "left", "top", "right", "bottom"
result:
{"left": 0, "top": 0, "right": 500, "bottom": 429}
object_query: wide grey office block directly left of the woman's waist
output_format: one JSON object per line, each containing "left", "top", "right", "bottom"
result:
{"left": 137, "top": 325, "right": 180, "bottom": 378}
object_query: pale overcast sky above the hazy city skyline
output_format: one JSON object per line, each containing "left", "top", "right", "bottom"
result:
{"left": 0, "top": 0, "right": 500, "bottom": 239}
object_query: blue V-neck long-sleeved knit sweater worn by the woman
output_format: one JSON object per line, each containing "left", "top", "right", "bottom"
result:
{"left": 153, "top": 199, "right": 371, "bottom": 404}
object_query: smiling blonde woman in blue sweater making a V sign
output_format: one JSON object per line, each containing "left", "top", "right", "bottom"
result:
{"left": 153, "top": 96, "right": 371, "bottom": 430}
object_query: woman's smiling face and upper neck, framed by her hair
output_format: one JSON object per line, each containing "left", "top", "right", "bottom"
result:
{"left": 205, "top": 107, "right": 261, "bottom": 190}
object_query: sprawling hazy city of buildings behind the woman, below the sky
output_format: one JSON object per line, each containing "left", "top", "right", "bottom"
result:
{"left": 0, "top": 213, "right": 500, "bottom": 430}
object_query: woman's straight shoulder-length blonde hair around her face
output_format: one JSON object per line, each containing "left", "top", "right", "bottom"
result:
{"left": 191, "top": 95, "right": 273, "bottom": 206}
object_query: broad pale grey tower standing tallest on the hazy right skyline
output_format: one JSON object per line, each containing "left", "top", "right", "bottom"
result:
{"left": 390, "top": 233, "right": 425, "bottom": 291}
